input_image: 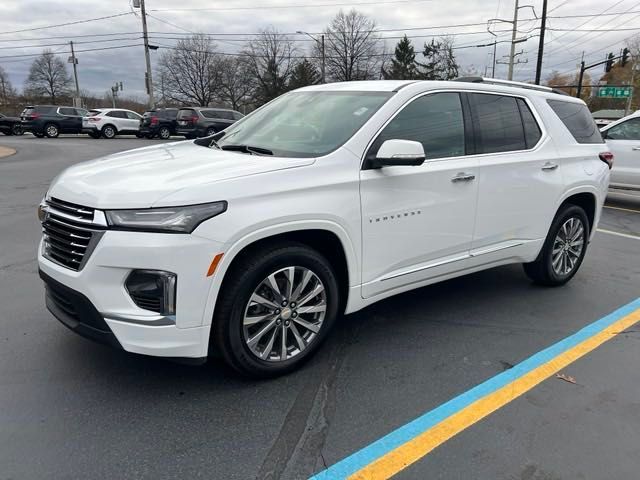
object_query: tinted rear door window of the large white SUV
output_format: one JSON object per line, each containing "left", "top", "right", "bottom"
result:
{"left": 469, "top": 93, "right": 527, "bottom": 153}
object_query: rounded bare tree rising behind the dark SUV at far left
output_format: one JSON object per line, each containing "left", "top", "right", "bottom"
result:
{"left": 25, "top": 50, "right": 71, "bottom": 103}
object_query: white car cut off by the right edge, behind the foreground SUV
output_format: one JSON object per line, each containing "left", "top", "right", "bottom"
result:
{"left": 601, "top": 111, "right": 640, "bottom": 190}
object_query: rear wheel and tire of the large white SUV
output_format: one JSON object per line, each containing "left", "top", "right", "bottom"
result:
{"left": 523, "top": 204, "right": 589, "bottom": 287}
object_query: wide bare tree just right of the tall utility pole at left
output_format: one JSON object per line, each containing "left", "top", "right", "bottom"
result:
{"left": 155, "top": 34, "right": 222, "bottom": 107}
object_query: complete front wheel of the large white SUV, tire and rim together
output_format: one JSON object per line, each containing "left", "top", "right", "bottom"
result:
{"left": 209, "top": 242, "right": 340, "bottom": 378}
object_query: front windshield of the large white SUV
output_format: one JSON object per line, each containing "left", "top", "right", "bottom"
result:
{"left": 218, "top": 91, "right": 393, "bottom": 157}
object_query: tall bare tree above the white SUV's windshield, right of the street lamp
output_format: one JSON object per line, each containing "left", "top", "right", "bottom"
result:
{"left": 314, "top": 9, "right": 383, "bottom": 82}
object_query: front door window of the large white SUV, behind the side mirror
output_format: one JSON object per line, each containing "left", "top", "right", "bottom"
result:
{"left": 367, "top": 93, "right": 465, "bottom": 158}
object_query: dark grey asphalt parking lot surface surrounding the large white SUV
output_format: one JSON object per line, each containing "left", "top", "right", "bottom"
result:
{"left": 0, "top": 135, "right": 640, "bottom": 480}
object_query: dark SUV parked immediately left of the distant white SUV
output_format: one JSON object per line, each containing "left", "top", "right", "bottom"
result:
{"left": 20, "top": 105, "right": 87, "bottom": 138}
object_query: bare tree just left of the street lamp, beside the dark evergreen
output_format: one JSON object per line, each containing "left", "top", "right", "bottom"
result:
{"left": 243, "top": 27, "right": 296, "bottom": 104}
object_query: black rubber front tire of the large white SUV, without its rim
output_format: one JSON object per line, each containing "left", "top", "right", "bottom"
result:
{"left": 214, "top": 246, "right": 339, "bottom": 377}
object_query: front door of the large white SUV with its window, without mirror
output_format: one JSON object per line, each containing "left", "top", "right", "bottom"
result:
{"left": 360, "top": 92, "right": 478, "bottom": 298}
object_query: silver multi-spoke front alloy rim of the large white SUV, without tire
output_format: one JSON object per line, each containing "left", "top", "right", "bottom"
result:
{"left": 242, "top": 266, "right": 327, "bottom": 362}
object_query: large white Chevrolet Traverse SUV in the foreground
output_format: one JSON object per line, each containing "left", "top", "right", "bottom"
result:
{"left": 38, "top": 79, "right": 611, "bottom": 376}
